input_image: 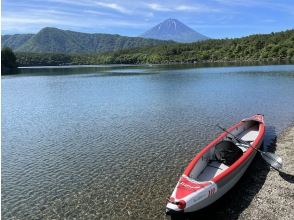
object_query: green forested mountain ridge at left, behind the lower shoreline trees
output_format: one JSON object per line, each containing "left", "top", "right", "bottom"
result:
{"left": 1, "top": 27, "right": 172, "bottom": 53}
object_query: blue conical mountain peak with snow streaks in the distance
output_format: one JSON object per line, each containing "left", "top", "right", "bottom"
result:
{"left": 140, "top": 19, "right": 209, "bottom": 43}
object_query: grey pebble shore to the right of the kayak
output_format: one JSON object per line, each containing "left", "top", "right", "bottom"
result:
{"left": 240, "top": 126, "right": 294, "bottom": 220}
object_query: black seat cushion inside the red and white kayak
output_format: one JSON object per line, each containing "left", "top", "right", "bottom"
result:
{"left": 215, "top": 141, "right": 243, "bottom": 166}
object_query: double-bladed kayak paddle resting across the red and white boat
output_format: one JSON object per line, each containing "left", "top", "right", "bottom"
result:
{"left": 216, "top": 124, "right": 283, "bottom": 171}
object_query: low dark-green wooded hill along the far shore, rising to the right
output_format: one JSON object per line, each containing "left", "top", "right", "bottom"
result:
{"left": 16, "top": 30, "right": 294, "bottom": 66}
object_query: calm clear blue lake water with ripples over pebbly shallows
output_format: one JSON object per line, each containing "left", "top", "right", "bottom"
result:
{"left": 2, "top": 65, "right": 294, "bottom": 219}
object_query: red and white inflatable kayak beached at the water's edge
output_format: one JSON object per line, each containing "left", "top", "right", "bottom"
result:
{"left": 166, "top": 114, "right": 265, "bottom": 214}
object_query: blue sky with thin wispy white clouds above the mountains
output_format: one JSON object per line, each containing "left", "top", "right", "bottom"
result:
{"left": 1, "top": 0, "right": 294, "bottom": 38}
